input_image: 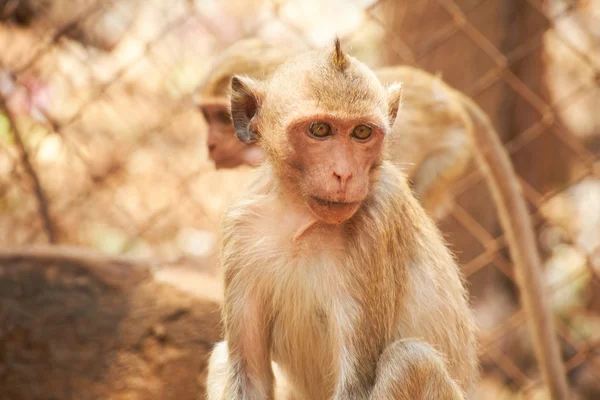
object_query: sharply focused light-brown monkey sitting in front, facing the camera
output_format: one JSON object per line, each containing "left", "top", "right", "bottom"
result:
{"left": 207, "top": 40, "right": 478, "bottom": 400}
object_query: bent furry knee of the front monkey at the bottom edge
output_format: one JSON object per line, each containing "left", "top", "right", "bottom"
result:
{"left": 370, "top": 340, "right": 465, "bottom": 400}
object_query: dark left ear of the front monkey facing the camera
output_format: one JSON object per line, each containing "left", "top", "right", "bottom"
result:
{"left": 230, "top": 75, "right": 264, "bottom": 144}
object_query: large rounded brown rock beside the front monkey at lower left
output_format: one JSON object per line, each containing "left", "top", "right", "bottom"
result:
{"left": 0, "top": 248, "right": 220, "bottom": 400}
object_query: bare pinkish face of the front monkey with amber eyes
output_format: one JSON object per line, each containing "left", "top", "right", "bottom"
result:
{"left": 283, "top": 115, "right": 385, "bottom": 224}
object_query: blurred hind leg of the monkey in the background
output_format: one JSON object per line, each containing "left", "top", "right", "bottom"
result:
{"left": 412, "top": 148, "right": 470, "bottom": 220}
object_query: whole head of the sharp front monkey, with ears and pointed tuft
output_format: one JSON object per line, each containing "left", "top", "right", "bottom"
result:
{"left": 231, "top": 39, "right": 402, "bottom": 224}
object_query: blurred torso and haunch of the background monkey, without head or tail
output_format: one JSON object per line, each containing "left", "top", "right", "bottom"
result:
{"left": 375, "top": 66, "right": 472, "bottom": 220}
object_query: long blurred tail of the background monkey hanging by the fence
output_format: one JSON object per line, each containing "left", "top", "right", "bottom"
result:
{"left": 458, "top": 97, "right": 569, "bottom": 400}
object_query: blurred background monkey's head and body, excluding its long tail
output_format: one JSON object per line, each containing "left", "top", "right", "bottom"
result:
{"left": 195, "top": 39, "right": 473, "bottom": 220}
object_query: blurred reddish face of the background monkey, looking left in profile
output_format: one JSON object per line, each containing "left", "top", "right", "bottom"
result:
{"left": 200, "top": 104, "right": 264, "bottom": 169}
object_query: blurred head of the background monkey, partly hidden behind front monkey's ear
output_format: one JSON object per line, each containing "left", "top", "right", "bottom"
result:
{"left": 197, "top": 38, "right": 292, "bottom": 169}
